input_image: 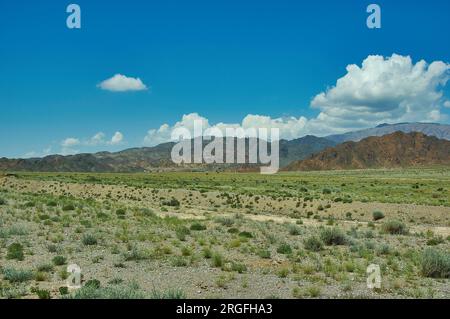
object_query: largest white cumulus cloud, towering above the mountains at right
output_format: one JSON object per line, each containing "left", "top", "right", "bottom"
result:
{"left": 311, "top": 54, "right": 450, "bottom": 129}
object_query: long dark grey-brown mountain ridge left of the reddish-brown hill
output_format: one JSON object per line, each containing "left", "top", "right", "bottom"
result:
{"left": 0, "top": 136, "right": 336, "bottom": 172}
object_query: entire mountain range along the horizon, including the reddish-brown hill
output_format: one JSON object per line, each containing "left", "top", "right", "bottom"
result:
{"left": 0, "top": 123, "right": 450, "bottom": 172}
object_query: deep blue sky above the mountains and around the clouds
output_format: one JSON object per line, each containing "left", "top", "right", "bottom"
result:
{"left": 0, "top": 0, "right": 450, "bottom": 157}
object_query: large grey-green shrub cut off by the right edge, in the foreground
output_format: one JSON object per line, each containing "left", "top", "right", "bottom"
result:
{"left": 421, "top": 248, "right": 450, "bottom": 278}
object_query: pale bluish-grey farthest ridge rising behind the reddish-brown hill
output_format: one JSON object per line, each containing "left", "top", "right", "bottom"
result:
{"left": 325, "top": 123, "right": 450, "bottom": 144}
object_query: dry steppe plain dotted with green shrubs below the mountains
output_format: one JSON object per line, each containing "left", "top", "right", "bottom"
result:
{"left": 0, "top": 168, "right": 450, "bottom": 298}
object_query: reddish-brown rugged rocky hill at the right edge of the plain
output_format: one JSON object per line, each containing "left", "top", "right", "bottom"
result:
{"left": 285, "top": 132, "right": 450, "bottom": 171}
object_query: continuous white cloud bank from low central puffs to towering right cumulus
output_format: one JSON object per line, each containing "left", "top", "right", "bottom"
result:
{"left": 144, "top": 54, "right": 450, "bottom": 145}
